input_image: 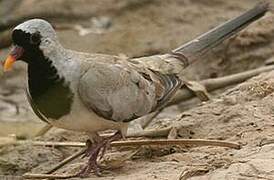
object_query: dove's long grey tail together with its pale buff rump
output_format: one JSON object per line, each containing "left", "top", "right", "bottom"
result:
{"left": 132, "top": 2, "right": 269, "bottom": 74}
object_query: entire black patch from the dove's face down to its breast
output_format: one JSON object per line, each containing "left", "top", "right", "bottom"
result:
{"left": 12, "top": 29, "right": 73, "bottom": 120}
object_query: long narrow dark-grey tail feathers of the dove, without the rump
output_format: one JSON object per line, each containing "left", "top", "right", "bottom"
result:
{"left": 172, "top": 2, "right": 269, "bottom": 65}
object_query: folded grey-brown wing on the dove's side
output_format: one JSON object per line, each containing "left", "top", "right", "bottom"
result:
{"left": 78, "top": 63, "right": 179, "bottom": 122}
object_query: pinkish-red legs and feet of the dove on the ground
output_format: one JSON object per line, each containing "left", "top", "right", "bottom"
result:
{"left": 75, "top": 131, "right": 122, "bottom": 177}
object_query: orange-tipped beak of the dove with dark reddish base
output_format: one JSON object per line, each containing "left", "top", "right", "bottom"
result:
{"left": 4, "top": 46, "right": 24, "bottom": 72}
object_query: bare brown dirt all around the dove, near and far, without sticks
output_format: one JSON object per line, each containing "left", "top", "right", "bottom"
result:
{"left": 0, "top": 0, "right": 274, "bottom": 180}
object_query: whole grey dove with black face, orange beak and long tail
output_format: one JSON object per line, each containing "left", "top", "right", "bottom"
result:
{"left": 3, "top": 3, "right": 269, "bottom": 177}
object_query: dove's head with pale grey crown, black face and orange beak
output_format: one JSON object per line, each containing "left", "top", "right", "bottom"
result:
{"left": 4, "top": 19, "right": 58, "bottom": 71}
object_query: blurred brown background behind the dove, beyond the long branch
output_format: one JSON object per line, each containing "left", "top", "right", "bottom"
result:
{"left": 0, "top": 0, "right": 274, "bottom": 179}
